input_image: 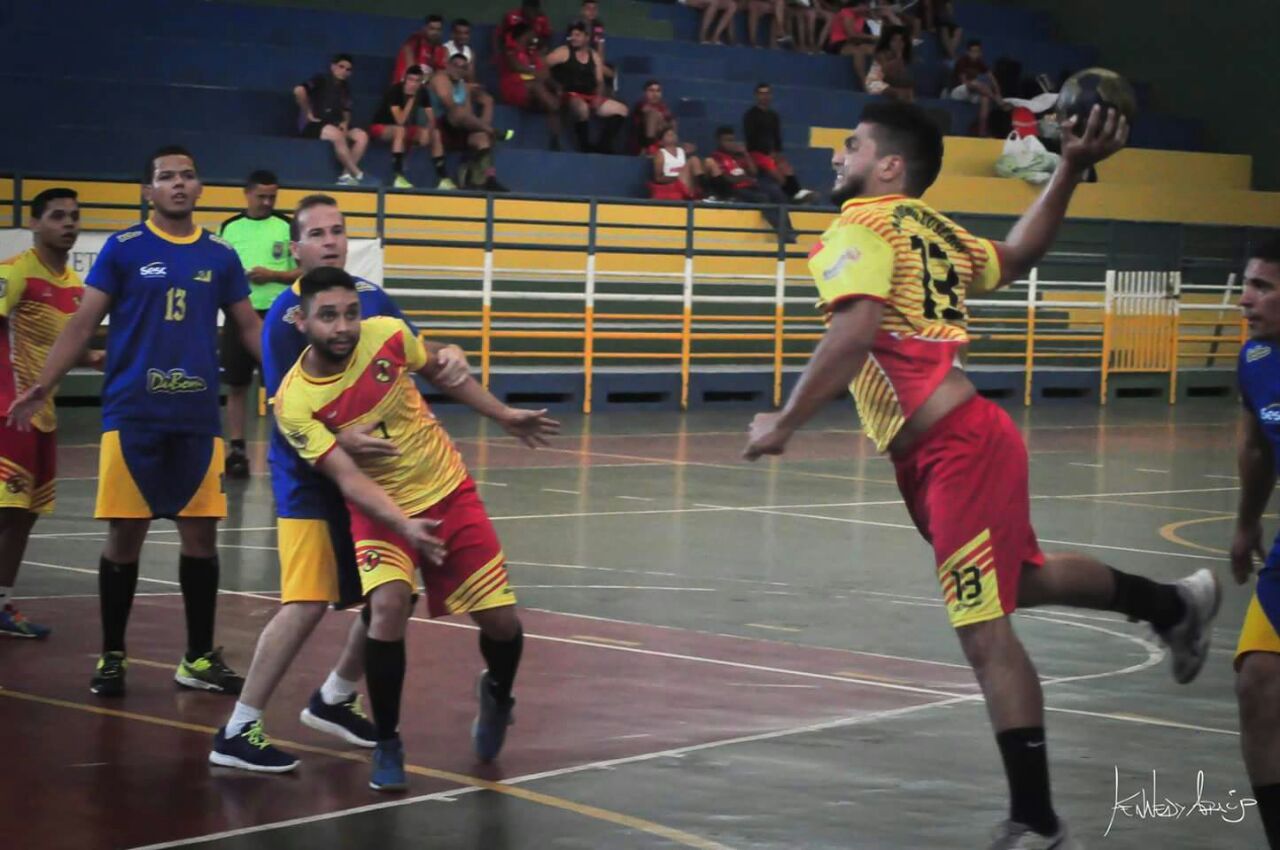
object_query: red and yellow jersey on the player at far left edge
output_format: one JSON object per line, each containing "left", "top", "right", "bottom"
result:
{"left": 0, "top": 248, "right": 84, "bottom": 431}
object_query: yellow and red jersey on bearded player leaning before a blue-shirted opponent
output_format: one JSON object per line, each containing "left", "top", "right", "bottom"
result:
{"left": 275, "top": 316, "right": 467, "bottom": 516}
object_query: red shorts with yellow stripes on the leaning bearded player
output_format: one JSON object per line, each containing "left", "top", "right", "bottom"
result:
{"left": 347, "top": 477, "right": 516, "bottom": 617}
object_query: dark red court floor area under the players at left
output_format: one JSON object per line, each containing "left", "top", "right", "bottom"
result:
{"left": 0, "top": 594, "right": 973, "bottom": 850}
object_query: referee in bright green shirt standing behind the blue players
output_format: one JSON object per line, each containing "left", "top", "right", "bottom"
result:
{"left": 218, "top": 170, "right": 297, "bottom": 479}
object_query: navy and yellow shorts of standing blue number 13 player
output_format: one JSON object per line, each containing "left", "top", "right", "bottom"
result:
{"left": 93, "top": 429, "right": 227, "bottom": 520}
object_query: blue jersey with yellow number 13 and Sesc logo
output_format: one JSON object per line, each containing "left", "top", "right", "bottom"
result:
{"left": 84, "top": 221, "right": 248, "bottom": 437}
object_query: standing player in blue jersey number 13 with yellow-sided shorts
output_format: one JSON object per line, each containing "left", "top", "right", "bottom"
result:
{"left": 9, "top": 146, "right": 261, "bottom": 696}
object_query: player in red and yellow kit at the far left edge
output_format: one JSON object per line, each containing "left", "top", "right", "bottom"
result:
{"left": 0, "top": 188, "right": 102, "bottom": 638}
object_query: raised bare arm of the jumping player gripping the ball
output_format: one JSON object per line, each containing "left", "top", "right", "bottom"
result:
{"left": 991, "top": 106, "right": 1129, "bottom": 288}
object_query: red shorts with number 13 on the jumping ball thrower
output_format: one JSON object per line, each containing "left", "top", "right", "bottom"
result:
{"left": 893, "top": 396, "right": 1044, "bottom": 627}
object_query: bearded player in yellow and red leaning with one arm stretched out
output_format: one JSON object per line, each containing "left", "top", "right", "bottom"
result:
{"left": 275, "top": 268, "right": 559, "bottom": 791}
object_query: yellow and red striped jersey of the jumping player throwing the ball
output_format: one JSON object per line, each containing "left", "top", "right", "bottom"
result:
{"left": 809, "top": 195, "right": 1000, "bottom": 452}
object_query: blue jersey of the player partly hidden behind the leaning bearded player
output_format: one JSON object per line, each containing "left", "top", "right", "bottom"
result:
{"left": 262, "top": 278, "right": 412, "bottom": 520}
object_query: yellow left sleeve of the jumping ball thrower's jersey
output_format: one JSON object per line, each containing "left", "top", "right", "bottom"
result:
{"left": 809, "top": 224, "right": 893, "bottom": 312}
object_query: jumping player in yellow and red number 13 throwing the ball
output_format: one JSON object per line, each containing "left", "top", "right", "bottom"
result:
{"left": 744, "top": 104, "right": 1220, "bottom": 850}
